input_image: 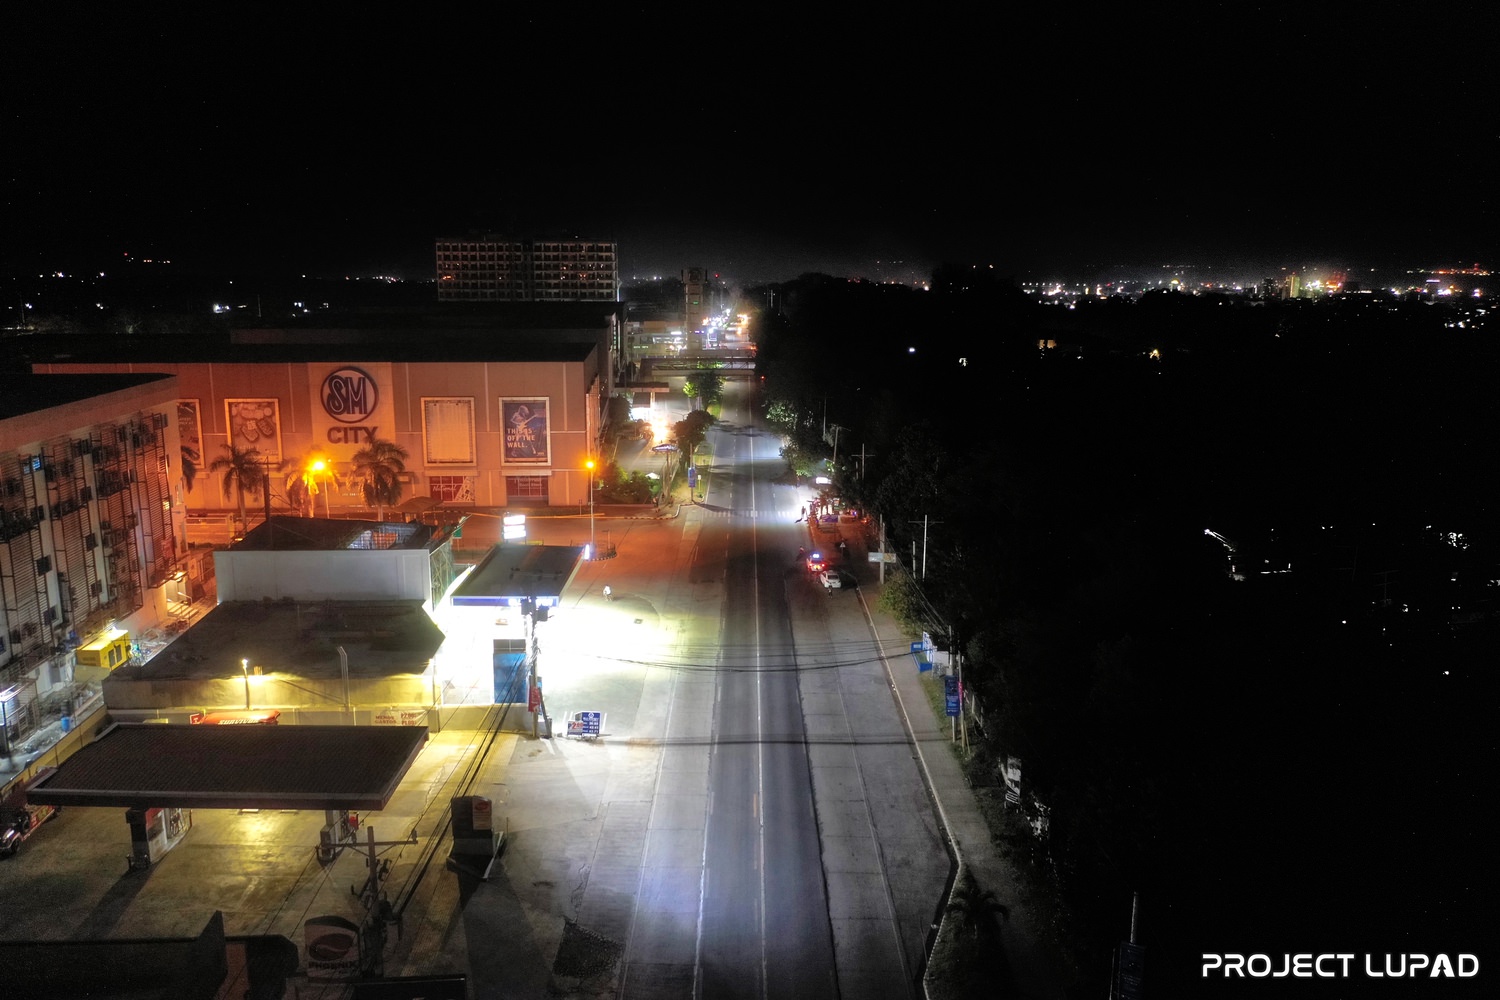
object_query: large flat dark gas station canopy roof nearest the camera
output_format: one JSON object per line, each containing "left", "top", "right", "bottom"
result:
{"left": 26, "top": 723, "right": 428, "bottom": 811}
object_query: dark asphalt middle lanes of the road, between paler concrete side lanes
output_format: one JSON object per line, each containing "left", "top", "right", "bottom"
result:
{"left": 699, "top": 391, "right": 837, "bottom": 997}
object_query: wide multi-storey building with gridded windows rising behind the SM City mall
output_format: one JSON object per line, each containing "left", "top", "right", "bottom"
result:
{"left": 437, "top": 235, "right": 620, "bottom": 301}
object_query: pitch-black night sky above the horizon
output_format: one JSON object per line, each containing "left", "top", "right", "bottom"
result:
{"left": 0, "top": 4, "right": 1500, "bottom": 282}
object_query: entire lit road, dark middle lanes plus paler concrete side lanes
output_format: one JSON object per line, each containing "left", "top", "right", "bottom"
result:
{"left": 620, "top": 377, "right": 924, "bottom": 1000}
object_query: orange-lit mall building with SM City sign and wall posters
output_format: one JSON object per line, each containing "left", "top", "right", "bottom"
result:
{"left": 33, "top": 313, "right": 615, "bottom": 516}
